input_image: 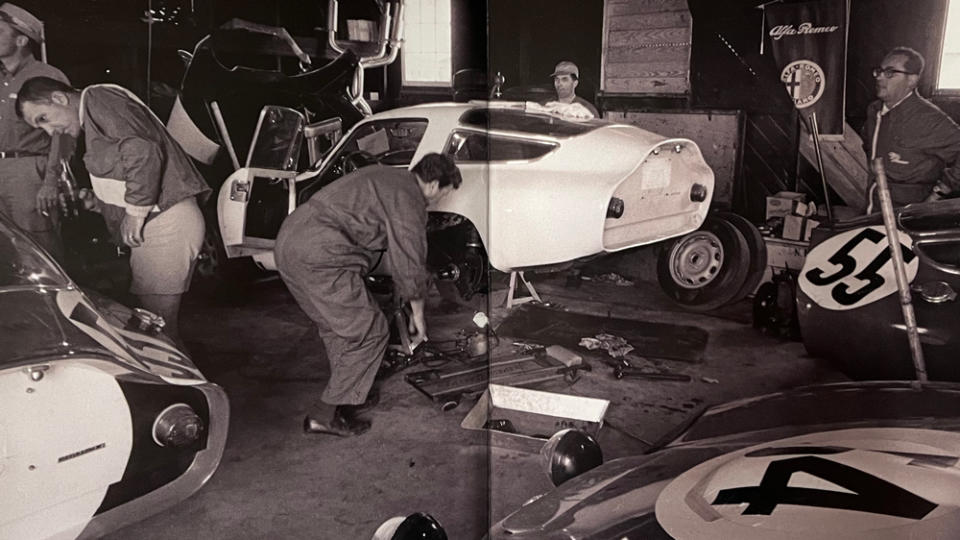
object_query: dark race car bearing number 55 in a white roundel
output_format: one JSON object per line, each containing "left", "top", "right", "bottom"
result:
{"left": 797, "top": 199, "right": 960, "bottom": 381}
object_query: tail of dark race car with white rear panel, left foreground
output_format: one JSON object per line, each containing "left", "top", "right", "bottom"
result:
{"left": 0, "top": 215, "right": 229, "bottom": 539}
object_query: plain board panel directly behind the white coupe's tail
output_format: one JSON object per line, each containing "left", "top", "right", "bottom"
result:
{"left": 606, "top": 111, "right": 740, "bottom": 205}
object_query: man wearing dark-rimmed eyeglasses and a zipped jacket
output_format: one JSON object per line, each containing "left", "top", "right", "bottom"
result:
{"left": 863, "top": 47, "right": 960, "bottom": 213}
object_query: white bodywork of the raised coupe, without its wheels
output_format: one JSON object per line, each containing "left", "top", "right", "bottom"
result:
{"left": 218, "top": 102, "right": 714, "bottom": 272}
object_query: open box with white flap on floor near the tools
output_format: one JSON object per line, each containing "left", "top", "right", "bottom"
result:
{"left": 460, "top": 384, "right": 610, "bottom": 453}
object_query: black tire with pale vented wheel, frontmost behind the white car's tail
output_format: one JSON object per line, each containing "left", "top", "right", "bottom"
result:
{"left": 657, "top": 214, "right": 750, "bottom": 311}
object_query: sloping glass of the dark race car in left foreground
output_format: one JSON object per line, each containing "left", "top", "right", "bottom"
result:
{"left": 0, "top": 218, "right": 70, "bottom": 291}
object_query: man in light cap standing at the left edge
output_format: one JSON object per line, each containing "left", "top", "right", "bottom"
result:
{"left": 0, "top": 2, "right": 73, "bottom": 257}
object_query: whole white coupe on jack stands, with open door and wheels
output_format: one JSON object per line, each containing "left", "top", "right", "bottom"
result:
{"left": 217, "top": 101, "right": 752, "bottom": 308}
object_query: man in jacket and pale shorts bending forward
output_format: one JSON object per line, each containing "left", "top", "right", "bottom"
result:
{"left": 17, "top": 77, "right": 210, "bottom": 348}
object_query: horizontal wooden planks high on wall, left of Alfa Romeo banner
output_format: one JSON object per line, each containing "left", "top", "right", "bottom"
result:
{"left": 600, "top": 0, "right": 693, "bottom": 95}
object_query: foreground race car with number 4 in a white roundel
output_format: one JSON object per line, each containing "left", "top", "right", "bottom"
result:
{"left": 487, "top": 381, "right": 960, "bottom": 540}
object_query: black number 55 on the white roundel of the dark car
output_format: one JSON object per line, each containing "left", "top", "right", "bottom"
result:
{"left": 805, "top": 229, "right": 916, "bottom": 306}
